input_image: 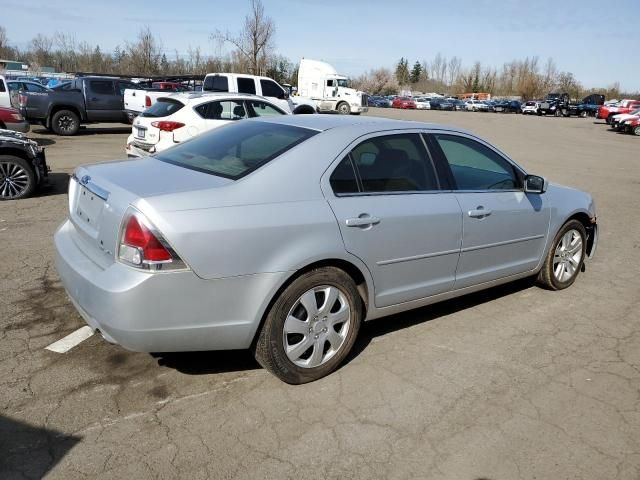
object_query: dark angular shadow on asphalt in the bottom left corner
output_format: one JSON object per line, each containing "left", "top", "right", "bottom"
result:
{"left": 0, "top": 415, "right": 82, "bottom": 478}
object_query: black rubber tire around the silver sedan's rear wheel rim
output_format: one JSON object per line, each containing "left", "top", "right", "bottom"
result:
{"left": 254, "top": 267, "right": 363, "bottom": 385}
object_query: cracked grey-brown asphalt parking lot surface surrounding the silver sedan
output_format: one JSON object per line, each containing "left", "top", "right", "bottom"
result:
{"left": 0, "top": 109, "right": 640, "bottom": 480}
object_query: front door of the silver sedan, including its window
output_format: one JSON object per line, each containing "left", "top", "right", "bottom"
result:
{"left": 433, "top": 134, "right": 549, "bottom": 289}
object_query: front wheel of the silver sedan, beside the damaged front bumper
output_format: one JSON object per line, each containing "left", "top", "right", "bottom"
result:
{"left": 538, "top": 220, "right": 587, "bottom": 290}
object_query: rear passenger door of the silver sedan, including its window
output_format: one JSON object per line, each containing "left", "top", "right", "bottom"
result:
{"left": 323, "top": 133, "right": 462, "bottom": 307}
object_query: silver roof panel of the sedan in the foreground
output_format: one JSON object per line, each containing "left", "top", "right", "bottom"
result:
{"left": 250, "top": 114, "right": 476, "bottom": 137}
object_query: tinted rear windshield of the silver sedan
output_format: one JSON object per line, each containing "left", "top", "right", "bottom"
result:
{"left": 155, "top": 120, "right": 317, "bottom": 180}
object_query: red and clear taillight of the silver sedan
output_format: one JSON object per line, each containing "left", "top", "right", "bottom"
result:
{"left": 118, "top": 209, "right": 186, "bottom": 271}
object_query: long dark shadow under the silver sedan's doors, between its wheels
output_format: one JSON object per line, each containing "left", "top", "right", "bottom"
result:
{"left": 343, "top": 277, "right": 535, "bottom": 366}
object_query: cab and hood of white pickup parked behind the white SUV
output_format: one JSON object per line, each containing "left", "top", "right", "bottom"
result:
{"left": 202, "top": 73, "right": 316, "bottom": 114}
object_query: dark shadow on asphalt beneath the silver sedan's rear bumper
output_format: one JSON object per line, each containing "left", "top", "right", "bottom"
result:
{"left": 151, "top": 350, "right": 262, "bottom": 375}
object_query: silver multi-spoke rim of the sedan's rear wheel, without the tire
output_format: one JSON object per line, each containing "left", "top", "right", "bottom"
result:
{"left": 282, "top": 285, "right": 351, "bottom": 368}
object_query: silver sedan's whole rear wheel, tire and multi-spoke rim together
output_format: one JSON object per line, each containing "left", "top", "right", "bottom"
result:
{"left": 254, "top": 267, "right": 363, "bottom": 385}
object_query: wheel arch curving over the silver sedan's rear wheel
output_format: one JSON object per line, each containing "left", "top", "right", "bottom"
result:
{"left": 251, "top": 258, "right": 373, "bottom": 349}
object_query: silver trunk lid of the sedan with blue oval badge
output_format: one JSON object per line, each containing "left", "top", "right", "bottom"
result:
{"left": 69, "top": 157, "right": 233, "bottom": 268}
